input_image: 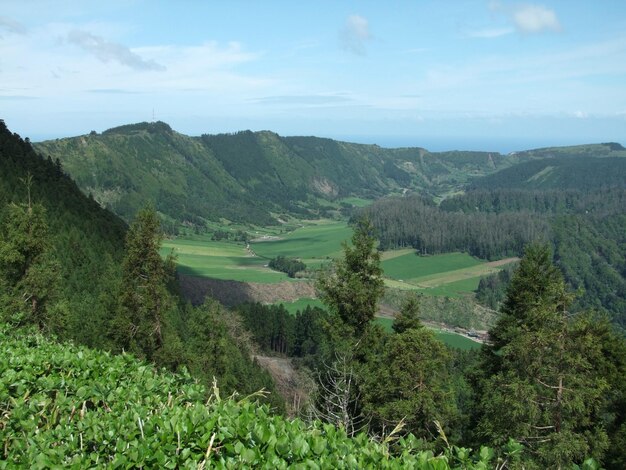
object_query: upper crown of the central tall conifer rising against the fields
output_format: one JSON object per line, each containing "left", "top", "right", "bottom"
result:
{"left": 317, "top": 219, "right": 384, "bottom": 338}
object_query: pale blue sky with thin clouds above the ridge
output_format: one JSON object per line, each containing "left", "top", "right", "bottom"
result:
{"left": 0, "top": 0, "right": 626, "bottom": 152}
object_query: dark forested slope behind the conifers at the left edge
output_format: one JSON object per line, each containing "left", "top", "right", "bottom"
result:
{"left": 0, "top": 120, "right": 126, "bottom": 347}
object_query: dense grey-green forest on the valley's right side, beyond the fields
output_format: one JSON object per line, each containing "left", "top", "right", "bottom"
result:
{"left": 365, "top": 188, "right": 626, "bottom": 328}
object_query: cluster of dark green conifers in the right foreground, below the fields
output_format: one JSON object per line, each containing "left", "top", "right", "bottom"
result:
{"left": 230, "top": 220, "right": 626, "bottom": 468}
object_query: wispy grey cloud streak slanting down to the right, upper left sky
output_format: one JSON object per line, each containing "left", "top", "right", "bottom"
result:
{"left": 66, "top": 30, "right": 165, "bottom": 70}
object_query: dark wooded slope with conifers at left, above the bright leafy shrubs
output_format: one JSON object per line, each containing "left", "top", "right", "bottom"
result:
{"left": 0, "top": 123, "right": 283, "bottom": 410}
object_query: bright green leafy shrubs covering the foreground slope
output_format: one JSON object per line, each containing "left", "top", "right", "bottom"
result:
{"left": 0, "top": 326, "right": 520, "bottom": 469}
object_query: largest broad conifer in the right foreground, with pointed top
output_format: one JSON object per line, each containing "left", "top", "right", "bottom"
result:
{"left": 477, "top": 245, "right": 609, "bottom": 468}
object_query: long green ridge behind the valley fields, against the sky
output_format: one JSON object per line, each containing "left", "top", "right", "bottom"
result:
{"left": 36, "top": 122, "right": 509, "bottom": 226}
